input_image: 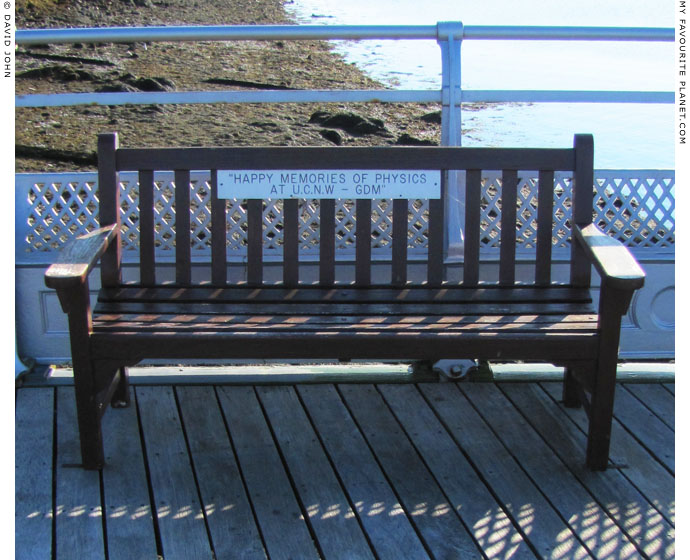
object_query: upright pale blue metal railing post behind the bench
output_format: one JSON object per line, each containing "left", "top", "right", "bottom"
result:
{"left": 436, "top": 21, "right": 465, "bottom": 257}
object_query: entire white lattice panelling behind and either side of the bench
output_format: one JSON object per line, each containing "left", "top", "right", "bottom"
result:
{"left": 16, "top": 170, "right": 675, "bottom": 258}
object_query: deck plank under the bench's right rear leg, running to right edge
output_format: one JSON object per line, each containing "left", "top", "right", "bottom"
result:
{"left": 541, "top": 382, "right": 676, "bottom": 525}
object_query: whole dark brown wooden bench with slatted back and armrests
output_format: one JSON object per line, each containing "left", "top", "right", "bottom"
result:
{"left": 45, "top": 134, "right": 644, "bottom": 469}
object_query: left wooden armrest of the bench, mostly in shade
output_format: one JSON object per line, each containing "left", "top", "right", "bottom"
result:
{"left": 45, "top": 224, "right": 118, "bottom": 289}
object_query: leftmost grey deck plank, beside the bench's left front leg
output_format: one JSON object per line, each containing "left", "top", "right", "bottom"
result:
{"left": 14, "top": 388, "right": 55, "bottom": 560}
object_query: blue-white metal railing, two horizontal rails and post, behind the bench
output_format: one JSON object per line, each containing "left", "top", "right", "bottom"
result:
{"left": 15, "top": 22, "right": 675, "bottom": 255}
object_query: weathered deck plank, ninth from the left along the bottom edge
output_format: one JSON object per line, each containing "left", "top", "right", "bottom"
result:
{"left": 339, "top": 385, "right": 481, "bottom": 558}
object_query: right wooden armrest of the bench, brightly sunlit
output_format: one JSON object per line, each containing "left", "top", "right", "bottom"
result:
{"left": 574, "top": 224, "right": 645, "bottom": 291}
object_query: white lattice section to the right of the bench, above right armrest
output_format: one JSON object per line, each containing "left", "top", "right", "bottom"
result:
{"left": 595, "top": 172, "right": 676, "bottom": 247}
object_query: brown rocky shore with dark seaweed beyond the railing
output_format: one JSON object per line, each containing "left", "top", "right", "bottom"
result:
{"left": 15, "top": 0, "right": 440, "bottom": 172}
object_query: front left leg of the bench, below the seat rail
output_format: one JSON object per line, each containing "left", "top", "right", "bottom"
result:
{"left": 74, "top": 363, "right": 105, "bottom": 470}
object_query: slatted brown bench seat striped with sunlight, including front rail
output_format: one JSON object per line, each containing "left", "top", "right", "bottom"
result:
{"left": 93, "top": 285, "right": 597, "bottom": 361}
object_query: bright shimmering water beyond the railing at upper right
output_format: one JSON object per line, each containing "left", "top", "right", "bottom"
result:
{"left": 287, "top": 0, "right": 675, "bottom": 169}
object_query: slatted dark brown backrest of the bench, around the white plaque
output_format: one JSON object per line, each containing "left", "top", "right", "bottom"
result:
{"left": 98, "top": 133, "right": 593, "bottom": 287}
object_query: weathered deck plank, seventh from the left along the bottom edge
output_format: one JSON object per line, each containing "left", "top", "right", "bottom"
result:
{"left": 257, "top": 386, "right": 374, "bottom": 559}
